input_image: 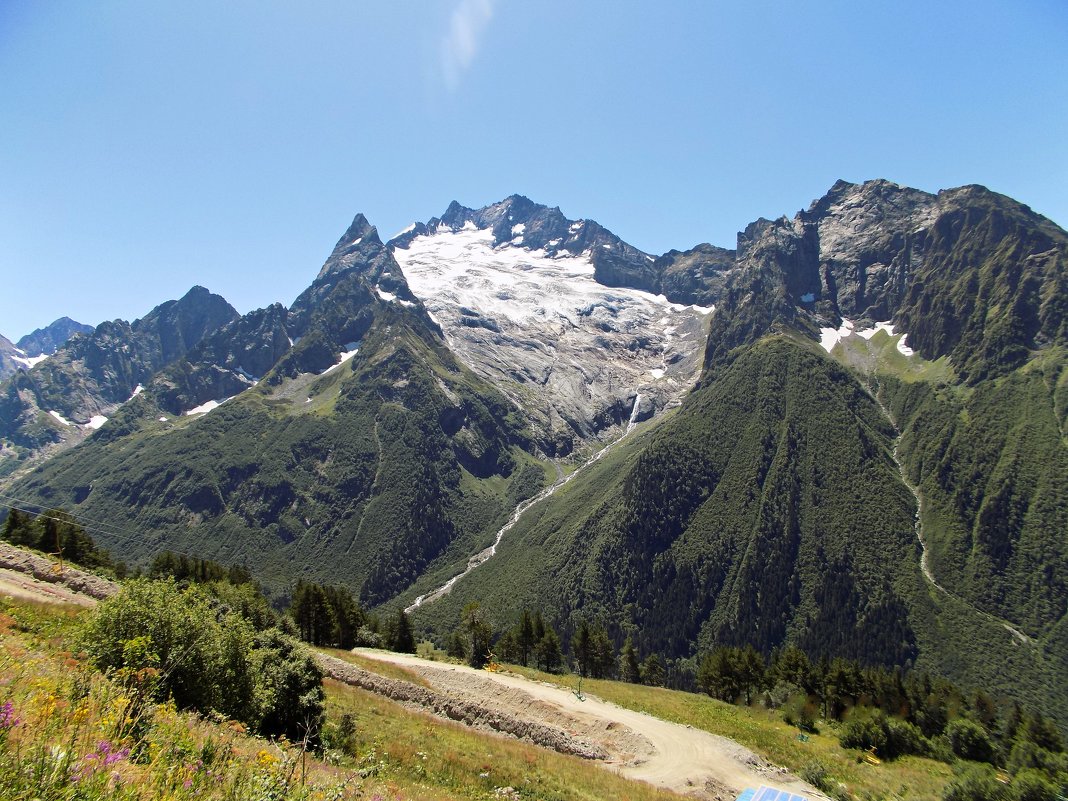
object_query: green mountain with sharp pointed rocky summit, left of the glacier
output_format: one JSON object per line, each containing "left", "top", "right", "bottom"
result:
{"left": 10, "top": 218, "right": 543, "bottom": 604}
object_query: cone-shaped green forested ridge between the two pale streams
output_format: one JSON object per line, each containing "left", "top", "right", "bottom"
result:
{"left": 407, "top": 336, "right": 918, "bottom": 664}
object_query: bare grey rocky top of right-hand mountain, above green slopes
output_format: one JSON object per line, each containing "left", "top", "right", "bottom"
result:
{"left": 706, "top": 180, "right": 1068, "bottom": 380}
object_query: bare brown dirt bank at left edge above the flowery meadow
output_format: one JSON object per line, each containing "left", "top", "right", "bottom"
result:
{"left": 0, "top": 543, "right": 119, "bottom": 607}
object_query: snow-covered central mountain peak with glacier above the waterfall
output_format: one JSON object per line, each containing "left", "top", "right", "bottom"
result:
{"left": 390, "top": 210, "right": 709, "bottom": 454}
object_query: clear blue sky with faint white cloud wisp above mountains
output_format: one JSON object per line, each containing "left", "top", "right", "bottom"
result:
{"left": 0, "top": 0, "right": 1068, "bottom": 339}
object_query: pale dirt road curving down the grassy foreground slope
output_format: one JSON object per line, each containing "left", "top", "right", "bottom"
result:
{"left": 356, "top": 648, "right": 826, "bottom": 800}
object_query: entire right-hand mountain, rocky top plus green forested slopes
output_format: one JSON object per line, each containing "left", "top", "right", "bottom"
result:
{"left": 417, "top": 182, "right": 1068, "bottom": 720}
